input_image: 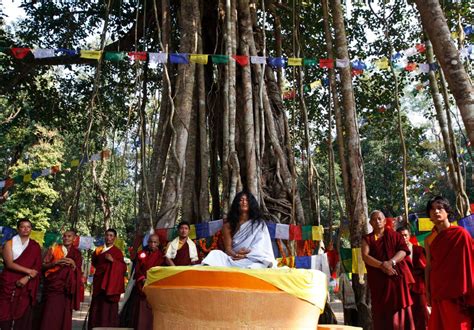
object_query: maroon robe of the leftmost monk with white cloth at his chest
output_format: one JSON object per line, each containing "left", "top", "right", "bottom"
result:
{"left": 0, "top": 238, "right": 41, "bottom": 330}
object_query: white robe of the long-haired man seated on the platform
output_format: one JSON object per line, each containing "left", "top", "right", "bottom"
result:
{"left": 202, "top": 220, "right": 277, "bottom": 269}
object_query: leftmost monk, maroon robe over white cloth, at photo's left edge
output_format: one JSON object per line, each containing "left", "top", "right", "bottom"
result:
{"left": 0, "top": 219, "right": 41, "bottom": 330}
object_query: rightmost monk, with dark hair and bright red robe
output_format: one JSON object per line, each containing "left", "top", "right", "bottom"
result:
{"left": 425, "top": 196, "right": 474, "bottom": 330}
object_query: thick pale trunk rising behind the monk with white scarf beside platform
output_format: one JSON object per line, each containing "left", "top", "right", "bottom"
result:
{"left": 157, "top": 0, "right": 199, "bottom": 228}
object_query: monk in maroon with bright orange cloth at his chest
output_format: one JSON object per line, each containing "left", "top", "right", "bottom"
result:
{"left": 41, "top": 230, "right": 82, "bottom": 330}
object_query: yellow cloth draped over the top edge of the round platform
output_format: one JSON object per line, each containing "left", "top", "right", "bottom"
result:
{"left": 145, "top": 266, "right": 328, "bottom": 311}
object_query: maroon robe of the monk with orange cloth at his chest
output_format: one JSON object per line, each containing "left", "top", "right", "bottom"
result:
{"left": 40, "top": 246, "right": 82, "bottom": 330}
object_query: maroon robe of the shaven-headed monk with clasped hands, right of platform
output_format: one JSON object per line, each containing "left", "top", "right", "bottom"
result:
{"left": 363, "top": 229, "right": 414, "bottom": 330}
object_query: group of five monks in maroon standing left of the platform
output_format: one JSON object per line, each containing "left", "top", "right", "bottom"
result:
{"left": 0, "top": 219, "right": 198, "bottom": 330}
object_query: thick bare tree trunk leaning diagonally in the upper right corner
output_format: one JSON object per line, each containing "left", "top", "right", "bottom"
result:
{"left": 415, "top": 0, "right": 474, "bottom": 143}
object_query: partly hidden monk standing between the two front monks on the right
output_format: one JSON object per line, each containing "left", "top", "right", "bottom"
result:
{"left": 397, "top": 227, "right": 429, "bottom": 330}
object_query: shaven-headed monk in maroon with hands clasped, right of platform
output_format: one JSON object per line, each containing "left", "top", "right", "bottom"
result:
{"left": 361, "top": 211, "right": 415, "bottom": 330}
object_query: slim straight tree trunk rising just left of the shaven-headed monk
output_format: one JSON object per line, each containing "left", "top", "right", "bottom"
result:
{"left": 331, "top": 0, "right": 371, "bottom": 329}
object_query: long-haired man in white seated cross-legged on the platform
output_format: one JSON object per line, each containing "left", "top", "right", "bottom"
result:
{"left": 202, "top": 191, "right": 276, "bottom": 268}
